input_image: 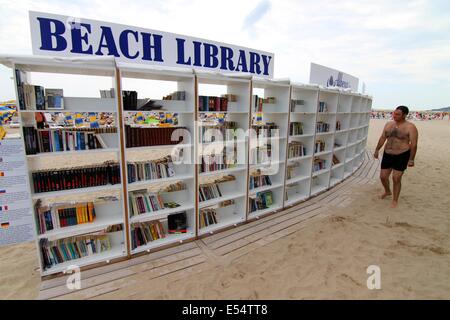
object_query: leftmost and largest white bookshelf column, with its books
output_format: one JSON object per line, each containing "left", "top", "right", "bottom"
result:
{"left": 6, "top": 57, "right": 127, "bottom": 276}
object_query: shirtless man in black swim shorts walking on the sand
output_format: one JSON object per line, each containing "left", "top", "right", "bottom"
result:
{"left": 373, "top": 106, "right": 418, "bottom": 208}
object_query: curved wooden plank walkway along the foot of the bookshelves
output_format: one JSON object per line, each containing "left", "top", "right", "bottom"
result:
{"left": 39, "top": 151, "right": 379, "bottom": 299}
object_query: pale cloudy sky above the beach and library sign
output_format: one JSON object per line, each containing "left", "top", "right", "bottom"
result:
{"left": 0, "top": 0, "right": 450, "bottom": 110}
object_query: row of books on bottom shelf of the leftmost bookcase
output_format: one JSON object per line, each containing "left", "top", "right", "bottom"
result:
{"left": 39, "top": 234, "right": 111, "bottom": 270}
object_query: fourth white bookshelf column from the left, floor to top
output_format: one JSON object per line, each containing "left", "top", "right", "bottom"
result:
{"left": 248, "top": 79, "right": 290, "bottom": 219}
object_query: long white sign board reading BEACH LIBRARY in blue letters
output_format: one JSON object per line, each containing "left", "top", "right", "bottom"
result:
{"left": 30, "top": 11, "right": 274, "bottom": 78}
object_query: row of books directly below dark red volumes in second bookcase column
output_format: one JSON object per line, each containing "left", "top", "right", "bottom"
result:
{"left": 127, "top": 156, "right": 175, "bottom": 183}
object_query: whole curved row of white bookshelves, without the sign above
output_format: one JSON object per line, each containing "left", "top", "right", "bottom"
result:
{"left": 0, "top": 56, "right": 372, "bottom": 276}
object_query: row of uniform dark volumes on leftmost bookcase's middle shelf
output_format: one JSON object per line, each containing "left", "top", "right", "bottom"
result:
{"left": 32, "top": 162, "right": 120, "bottom": 193}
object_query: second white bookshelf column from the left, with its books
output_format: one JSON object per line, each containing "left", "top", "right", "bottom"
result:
{"left": 118, "top": 63, "right": 196, "bottom": 254}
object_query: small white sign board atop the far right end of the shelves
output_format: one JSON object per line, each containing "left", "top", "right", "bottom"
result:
{"left": 309, "top": 63, "right": 359, "bottom": 92}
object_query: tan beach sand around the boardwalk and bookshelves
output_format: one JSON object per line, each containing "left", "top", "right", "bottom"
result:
{"left": 0, "top": 120, "right": 450, "bottom": 299}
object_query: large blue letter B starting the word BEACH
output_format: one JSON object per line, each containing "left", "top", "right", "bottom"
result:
{"left": 37, "top": 18, "right": 67, "bottom": 51}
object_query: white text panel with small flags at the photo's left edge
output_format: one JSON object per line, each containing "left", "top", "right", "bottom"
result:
{"left": 0, "top": 138, "right": 35, "bottom": 246}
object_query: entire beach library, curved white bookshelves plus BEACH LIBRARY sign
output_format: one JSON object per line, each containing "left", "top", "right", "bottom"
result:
{"left": 0, "top": 13, "right": 372, "bottom": 277}
